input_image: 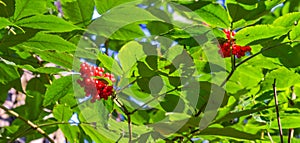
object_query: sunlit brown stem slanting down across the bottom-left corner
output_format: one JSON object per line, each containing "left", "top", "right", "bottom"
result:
{"left": 0, "top": 105, "right": 54, "bottom": 143}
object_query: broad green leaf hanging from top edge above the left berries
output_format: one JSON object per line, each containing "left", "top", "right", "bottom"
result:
{"left": 60, "top": 0, "right": 95, "bottom": 27}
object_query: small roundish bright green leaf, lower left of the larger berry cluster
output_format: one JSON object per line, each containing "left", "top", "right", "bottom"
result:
{"left": 53, "top": 104, "right": 73, "bottom": 122}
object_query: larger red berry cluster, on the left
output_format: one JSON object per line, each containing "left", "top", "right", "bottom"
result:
{"left": 77, "top": 63, "right": 116, "bottom": 102}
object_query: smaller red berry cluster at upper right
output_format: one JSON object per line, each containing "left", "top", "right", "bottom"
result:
{"left": 219, "top": 29, "right": 251, "bottom": 58}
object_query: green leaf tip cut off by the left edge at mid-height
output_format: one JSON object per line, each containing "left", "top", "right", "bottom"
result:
{"left": 0, "top": 61, "right": 20, "bottom": 84}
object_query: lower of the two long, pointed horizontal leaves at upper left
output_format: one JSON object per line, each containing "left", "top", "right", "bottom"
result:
{"left": 18, "top": 33, "right": 76, "bottom": 52}
